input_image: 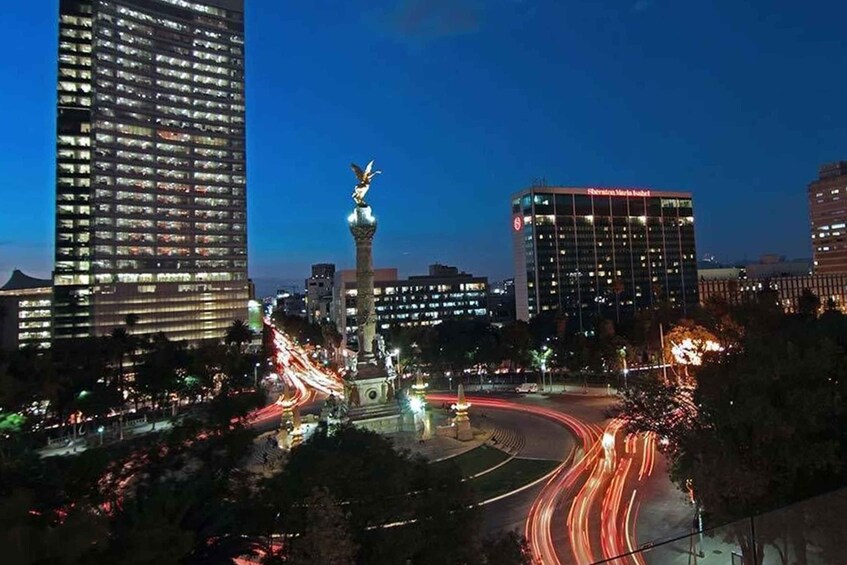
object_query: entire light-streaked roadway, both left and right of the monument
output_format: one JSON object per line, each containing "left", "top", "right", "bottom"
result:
{"left": 260, "top": 324, "right": 693, "bottom": 565}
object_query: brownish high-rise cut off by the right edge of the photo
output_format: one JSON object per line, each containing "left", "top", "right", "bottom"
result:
{"left": 809, "top": 161, "right": 847, "bottom": 274}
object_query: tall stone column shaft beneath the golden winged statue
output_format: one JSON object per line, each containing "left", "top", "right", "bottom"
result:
{"left": 348, "top": 206, "right": 376, "bottom": 364}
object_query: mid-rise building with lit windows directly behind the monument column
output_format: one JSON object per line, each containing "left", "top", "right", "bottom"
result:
{"left": 332, "top": 264, "right": 488, "bottom": 343}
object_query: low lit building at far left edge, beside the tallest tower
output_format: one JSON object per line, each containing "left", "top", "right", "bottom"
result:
{"left": 0, "top": 269, "right": 53, "bottom": 351}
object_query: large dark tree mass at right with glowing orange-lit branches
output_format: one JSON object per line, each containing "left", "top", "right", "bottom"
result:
{"left": 619, "top": 308, "right": 847, "bottom": 565}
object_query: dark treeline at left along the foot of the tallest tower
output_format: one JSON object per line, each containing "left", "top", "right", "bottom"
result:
{"left": 0, "top": 319, "right": 264, "bottom": 439}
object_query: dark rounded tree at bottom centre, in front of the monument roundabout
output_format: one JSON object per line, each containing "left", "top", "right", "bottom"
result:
{"left": 259, "top": 426, "right": 476, "bottom": 564}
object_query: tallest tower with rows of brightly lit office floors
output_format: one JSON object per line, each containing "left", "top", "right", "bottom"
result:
{"left": 54, "top": 0, "right": 248, "bottom": 341}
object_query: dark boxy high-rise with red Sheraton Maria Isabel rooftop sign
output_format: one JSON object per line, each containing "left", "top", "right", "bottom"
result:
{"left": 511, "top": 186, "right": 697, "bottom": 330}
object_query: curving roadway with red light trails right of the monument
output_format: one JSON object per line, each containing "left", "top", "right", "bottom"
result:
{"left": 430, "top": 394, "right": 693, "bottom": 565}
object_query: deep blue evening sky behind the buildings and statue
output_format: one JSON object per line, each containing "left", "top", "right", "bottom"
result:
{"left": 0, "top": 0, "right": 847, "bottom": 296}
